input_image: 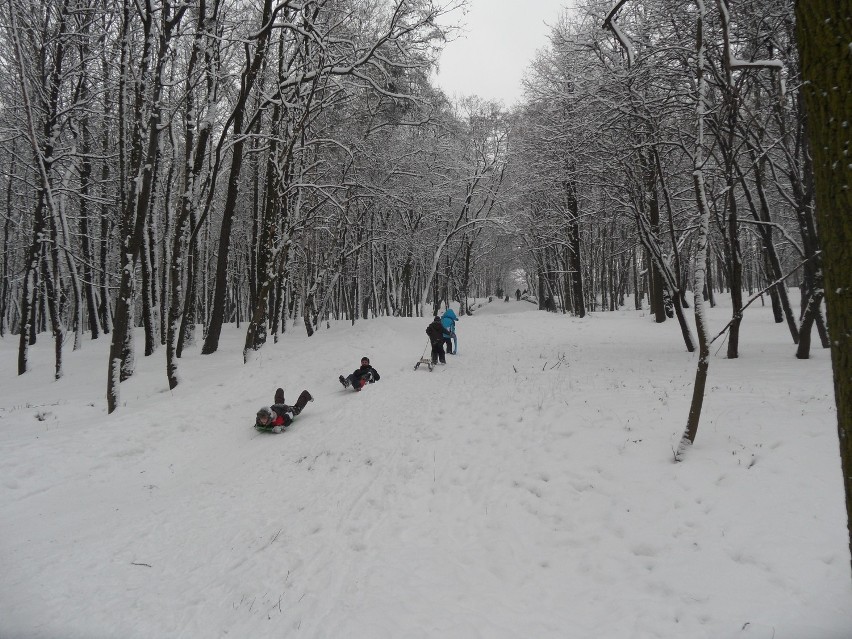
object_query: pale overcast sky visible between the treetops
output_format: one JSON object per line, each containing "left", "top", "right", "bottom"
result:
{"left": 436, "top": 0, "right": 571, "bottom": 107}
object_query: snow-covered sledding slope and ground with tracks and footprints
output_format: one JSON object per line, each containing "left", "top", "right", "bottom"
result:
{"left": 0, "top": 300, "right": 852, "bottom": 639}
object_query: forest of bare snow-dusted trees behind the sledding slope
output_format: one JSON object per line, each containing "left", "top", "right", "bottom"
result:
{"left": 0, "top": 0, "right": 840, "bottom": 424}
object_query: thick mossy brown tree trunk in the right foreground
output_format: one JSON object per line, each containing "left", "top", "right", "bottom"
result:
{"left": 796, "top": 0, "right": 852, "bottom": 576}
